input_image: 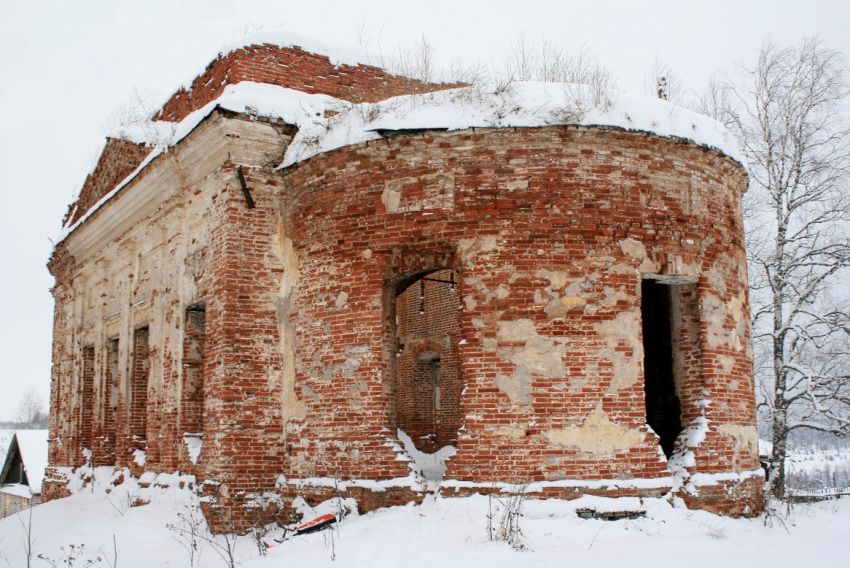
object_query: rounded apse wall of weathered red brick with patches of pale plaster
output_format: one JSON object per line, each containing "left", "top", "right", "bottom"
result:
{"left": 280, "top": 126, "right": 758, "bottom": 496}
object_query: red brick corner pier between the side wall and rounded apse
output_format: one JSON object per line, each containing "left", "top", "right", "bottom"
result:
{"left": 201, "top": 164, "right": 290, "bottom": 526}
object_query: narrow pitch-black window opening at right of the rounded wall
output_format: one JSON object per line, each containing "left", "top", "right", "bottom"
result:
{"left": 641, "top": 278, "right": 682, "bottom": 458}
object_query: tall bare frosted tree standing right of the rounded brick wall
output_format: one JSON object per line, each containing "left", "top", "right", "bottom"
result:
{"left": 720, "top": 39, "right": 850, "bottom": 497}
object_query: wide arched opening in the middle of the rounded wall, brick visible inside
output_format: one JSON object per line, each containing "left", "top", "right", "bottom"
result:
{"left": 392, "top": 269, "right": 462, "bottom": 453}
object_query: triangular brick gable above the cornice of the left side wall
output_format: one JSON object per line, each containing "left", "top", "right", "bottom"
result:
{"left": 63, "top": 138, "right": 151, "bottom": 225}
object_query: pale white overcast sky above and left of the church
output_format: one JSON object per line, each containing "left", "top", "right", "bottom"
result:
{"left": 0, "top": 0, "right": 850, "bottom": 420}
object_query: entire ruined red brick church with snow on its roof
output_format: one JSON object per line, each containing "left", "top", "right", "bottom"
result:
{"left": 44, "top": 32, "right": 763, "bottom": 529}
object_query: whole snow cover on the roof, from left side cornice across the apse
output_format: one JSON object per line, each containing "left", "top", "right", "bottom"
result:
{"left": 57, "top": 81, "right": 743, "bottom": 242}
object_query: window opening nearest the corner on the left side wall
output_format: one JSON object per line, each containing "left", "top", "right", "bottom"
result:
{"left": 181, "top": 303, "right": 206, "bottom": 435}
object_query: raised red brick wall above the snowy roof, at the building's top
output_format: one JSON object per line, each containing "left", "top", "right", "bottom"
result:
{"left": 156, "top": 44, "right": 457, "bottom": 121}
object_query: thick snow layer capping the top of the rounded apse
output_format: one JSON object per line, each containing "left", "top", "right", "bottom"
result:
{"left": 280, "top": 81, "right": 743, "bottom": 168}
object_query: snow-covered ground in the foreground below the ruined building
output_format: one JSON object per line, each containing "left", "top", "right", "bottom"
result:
{"left": 0, "top": 468, "right": 850, "bottom": 568}
